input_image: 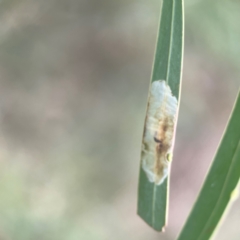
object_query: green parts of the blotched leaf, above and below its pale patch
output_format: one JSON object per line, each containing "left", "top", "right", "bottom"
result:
{"left": 138, "top": 0, "right": 183, "bottom": 231}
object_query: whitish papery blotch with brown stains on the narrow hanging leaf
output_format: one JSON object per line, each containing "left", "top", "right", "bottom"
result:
{"left": 141, "top": 80, "right": 177, "bottom": 185}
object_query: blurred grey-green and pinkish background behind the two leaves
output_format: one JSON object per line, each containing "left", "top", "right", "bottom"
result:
{"left": 0, "top": 0, "right": 240, "bottom": 240}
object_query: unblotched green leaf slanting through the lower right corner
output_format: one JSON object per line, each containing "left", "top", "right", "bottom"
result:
{"left": 178, "top": 91, "right": 240, "bottom": 240}
